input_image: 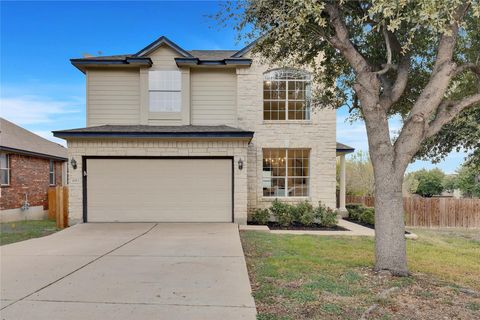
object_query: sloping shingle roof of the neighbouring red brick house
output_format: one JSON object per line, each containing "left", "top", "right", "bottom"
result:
{"left": 0, "top": 118, "right": 68, "bottom": 160}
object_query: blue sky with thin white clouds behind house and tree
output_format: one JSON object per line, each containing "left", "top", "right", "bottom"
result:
{"left": 0, "top": 0, "right": 465, "bottom": 173}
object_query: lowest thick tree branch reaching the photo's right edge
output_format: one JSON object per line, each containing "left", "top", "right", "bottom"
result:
{"left": 425, "top": 93, "right": 480, "bottom": 138}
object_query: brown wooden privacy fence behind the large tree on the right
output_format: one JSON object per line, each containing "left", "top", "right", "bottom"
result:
{"left": 346, "top": 196, "right": 480, "bottom": 228}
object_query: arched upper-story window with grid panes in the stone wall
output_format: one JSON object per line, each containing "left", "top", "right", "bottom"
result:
{"left": 263, "top": 69, "right": 311, "bottom": 120}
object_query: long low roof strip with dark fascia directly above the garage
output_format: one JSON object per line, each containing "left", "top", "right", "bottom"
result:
{"left": 53, "top": 125, "right": 254, "bottom": 139}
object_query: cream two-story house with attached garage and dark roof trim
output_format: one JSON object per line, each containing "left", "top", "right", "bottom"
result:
{"left": 54, "top": 37, "right": 353, "bottom": 224}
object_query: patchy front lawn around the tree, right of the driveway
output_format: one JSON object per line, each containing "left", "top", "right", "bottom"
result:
{"left": 241, "top": 229, "right": 480, "bottom": 319}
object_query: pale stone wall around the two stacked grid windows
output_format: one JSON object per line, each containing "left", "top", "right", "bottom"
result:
{"left": 237, "top": 59, "right": 336, "bottom": 219}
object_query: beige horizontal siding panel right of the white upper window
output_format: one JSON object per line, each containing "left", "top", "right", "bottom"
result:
{"left": 190, "top": 69, "right": 237, "bottom": 126}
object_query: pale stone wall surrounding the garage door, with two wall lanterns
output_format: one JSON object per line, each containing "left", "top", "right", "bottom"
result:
{"left": 68, "top": 139, "right": 248, "bottom": 225}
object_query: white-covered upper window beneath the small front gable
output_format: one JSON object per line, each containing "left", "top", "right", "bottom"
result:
{"left": 148, "top": 71, "right": 182, "bottom": 112}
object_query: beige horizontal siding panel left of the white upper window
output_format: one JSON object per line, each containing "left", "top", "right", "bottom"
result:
{"left": 87, "top": 69, "right": 140, "bottom": 126}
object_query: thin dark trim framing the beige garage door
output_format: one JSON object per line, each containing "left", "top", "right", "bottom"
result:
{"left": 82, "top": 156, "right": 235, "bottom": 223}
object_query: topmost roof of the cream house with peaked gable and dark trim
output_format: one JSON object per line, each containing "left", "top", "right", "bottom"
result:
{"left": 70, "top": 36, "right": 255, "bottom": 72}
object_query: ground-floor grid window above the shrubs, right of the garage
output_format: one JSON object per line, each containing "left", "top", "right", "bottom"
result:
{"left": 262, "top": 149, "right": 310, "bottom": 197}
